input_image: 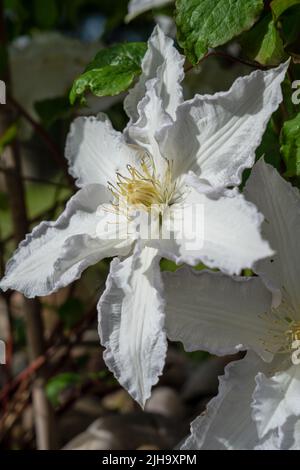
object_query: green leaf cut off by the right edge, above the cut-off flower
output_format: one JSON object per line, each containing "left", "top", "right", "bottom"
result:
{"left": 280, "top": 113, "right": 300, "bottom": 177}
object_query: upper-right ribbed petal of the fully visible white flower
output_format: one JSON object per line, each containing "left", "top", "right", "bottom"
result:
{"left": 159, "top": 63, "right": 288, "bottom": 188}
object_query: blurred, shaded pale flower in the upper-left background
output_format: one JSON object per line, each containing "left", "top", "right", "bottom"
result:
{"left": 9, "top": 32, "right": 120, "bottom": 135}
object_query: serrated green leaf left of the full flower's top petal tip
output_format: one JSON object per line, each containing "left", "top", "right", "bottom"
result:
{"left": 70, "top": 42, "right": 147, "bottom": 104}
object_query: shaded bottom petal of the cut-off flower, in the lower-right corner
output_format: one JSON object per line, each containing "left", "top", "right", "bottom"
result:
{"left": 182, "top": 352, "right": 276, "bottom": 450}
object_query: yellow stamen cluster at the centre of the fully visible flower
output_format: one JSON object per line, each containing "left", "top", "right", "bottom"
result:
{"left": 108, "top": 155, "right": 176, "bottom": 211}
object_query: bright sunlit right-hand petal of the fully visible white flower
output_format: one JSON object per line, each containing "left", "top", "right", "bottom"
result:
{"left": 161, "top": 189, "right": 273, "bottom": 274}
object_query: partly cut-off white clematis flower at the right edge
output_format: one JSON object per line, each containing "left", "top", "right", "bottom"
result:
{"left": 164, "top": 160, "right": 300, "bottom": 449}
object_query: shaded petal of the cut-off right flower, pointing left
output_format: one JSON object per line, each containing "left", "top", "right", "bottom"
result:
{"left": 164, "top": 267, "right": 272, "bottom": 360}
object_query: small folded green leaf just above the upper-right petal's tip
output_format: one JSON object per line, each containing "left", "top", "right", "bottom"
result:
{"left": 240, "top": 14, "right": 286, "bottom": 65}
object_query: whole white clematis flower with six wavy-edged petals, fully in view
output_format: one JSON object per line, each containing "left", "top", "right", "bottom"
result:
{"left": 0, "top": 27, "right": 287, "bottom": 404}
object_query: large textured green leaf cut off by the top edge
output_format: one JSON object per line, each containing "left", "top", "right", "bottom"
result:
{"left": 176, "top": 0, "right": 264, "bottom": 64}
